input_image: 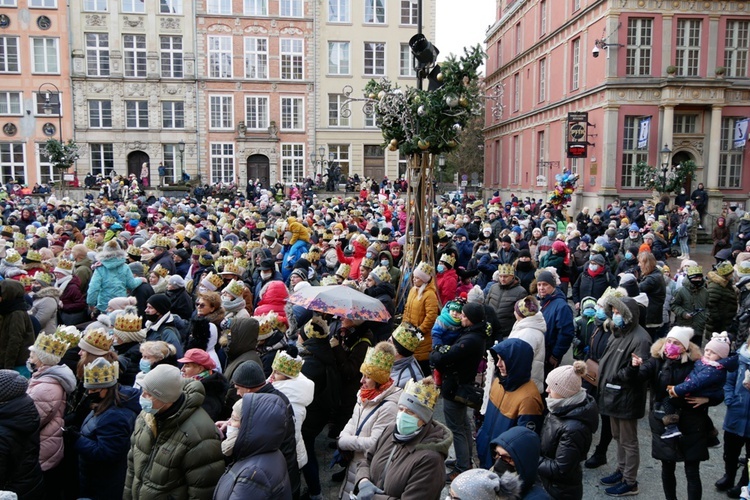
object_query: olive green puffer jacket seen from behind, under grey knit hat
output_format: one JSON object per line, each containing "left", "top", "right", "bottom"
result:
{"left": 123, "top": 380, "right": 224, "bottom": 500}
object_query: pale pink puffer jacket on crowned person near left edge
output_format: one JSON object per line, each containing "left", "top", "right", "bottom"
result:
{"left": 26, "top": 365, "right": 76, "bottom": 471}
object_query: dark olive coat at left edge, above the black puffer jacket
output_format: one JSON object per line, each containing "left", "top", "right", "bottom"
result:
{"left": 0, "top": 280, "right": 34, "bottom": 370}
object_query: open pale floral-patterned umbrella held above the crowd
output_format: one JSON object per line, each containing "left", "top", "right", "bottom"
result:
{"left": 289, "top": 285, "right": 391, "bottom": 323}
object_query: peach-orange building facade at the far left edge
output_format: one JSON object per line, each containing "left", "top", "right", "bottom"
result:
{"left": 0, "top": 0, "right": 73, "bottom": 187}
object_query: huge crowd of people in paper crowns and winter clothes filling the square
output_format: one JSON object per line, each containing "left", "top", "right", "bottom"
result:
{"left": 0, "top": 185, "right": 750, "bottom": 500}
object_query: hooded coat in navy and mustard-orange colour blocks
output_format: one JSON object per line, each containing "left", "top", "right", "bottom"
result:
{"left": 476, "top": 339, "right": 544, "bottom": 469}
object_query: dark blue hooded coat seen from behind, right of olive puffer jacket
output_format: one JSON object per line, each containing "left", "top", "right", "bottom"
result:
{"left": 213, "top": 394, "right": 292, "bottom": 500}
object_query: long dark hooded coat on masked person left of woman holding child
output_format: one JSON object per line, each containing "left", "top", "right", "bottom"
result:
{"left": 597, "top": 297, "right": 651, "bottom": 419}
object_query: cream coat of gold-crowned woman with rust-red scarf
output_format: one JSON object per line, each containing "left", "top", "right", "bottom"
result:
{"left": 338, "top": 384, "right": 401, "bottom": 499}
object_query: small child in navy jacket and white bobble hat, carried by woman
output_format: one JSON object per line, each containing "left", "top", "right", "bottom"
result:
{"left": 661, "top": 332, "right": 739, "bottom": 439}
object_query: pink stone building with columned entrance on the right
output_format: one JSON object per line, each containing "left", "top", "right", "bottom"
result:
{"left": 485, "top": 0, "right": 750, "bottom": 214}
